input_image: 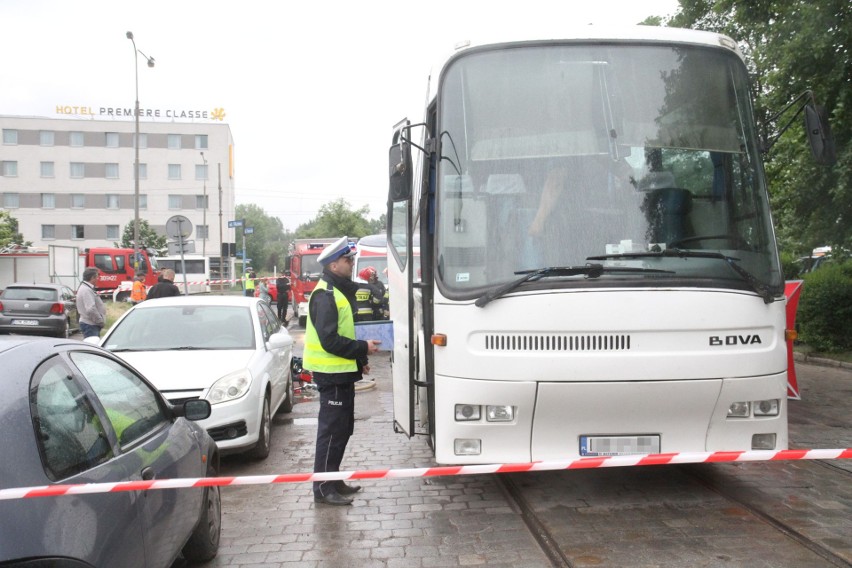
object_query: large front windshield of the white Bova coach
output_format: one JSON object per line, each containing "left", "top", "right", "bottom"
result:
{"left": 435, "top": 44, "right": 783, "bottom": 299}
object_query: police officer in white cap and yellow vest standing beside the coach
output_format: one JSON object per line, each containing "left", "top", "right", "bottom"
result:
{"left": 302, "top": 237, "right": 380, "bottom": 505}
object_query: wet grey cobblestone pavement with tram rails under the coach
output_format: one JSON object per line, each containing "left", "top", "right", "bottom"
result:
{"left": 201, "top": 328, "right": 852, "bottom": 568}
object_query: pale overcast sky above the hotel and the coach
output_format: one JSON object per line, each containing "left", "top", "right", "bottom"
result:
{"left": 0, "top": 0, "right": 677, "bottom": 230}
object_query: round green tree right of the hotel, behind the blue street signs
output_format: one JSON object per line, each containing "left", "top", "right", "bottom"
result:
{"left": 235, "top": 204, "right": 293, "bottom": 273}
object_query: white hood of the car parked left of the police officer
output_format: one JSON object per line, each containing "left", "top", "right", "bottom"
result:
{"left": 116, "top": 350, "right": 255, "bottom": 391}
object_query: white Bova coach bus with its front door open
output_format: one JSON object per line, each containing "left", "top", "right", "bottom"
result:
{"left": 388, "top": 26, "right": 828, "bottom": 464}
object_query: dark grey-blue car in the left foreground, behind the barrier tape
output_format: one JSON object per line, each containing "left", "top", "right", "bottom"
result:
{"left": 0, "top": 336, "right": 221, "bottom": 568}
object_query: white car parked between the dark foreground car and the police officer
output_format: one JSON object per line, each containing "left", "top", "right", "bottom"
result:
{"left": 100, "top": 296, "right": 293, "bottom": 459}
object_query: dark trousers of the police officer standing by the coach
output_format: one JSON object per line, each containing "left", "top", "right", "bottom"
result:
{"left": 314, "top": 373, "right": 355, "bottom": 496}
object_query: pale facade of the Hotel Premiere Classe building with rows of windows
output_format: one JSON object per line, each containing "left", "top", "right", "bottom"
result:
{"left": 0, "top": 116, "right": 235, "bottom": 273}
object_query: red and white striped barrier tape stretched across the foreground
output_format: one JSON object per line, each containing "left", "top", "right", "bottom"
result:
{"left": 0, "top": 448, "right": 852, "bottom": 501}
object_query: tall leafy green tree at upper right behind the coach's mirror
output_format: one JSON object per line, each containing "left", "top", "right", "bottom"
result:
{"left": 668, "top": 0, "right": 852, "bottom": 253}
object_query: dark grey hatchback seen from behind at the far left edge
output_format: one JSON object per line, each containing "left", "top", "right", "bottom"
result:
{"left": 0, "top": 283, "right": 79, "bottom": 337}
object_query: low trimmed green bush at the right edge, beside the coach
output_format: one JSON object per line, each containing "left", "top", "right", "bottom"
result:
{"left": 796, "top": 261, "right": 852, "bottom": 353}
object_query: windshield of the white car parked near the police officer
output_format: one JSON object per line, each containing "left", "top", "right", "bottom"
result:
{"left": 105, "top": 306, "right": 256, "bottom": 351}
